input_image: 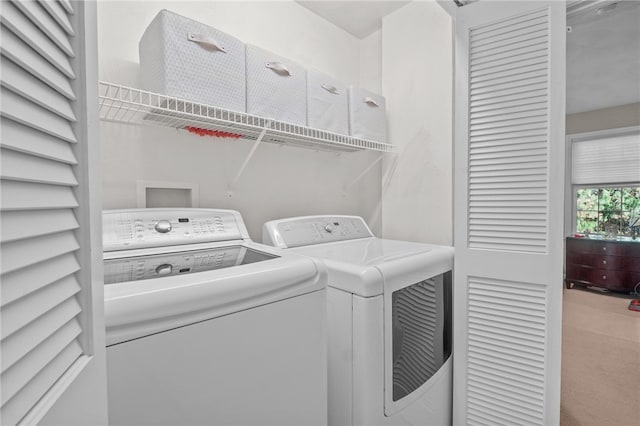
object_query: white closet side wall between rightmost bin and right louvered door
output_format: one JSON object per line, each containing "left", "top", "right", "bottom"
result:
{"left": 382, "top": 1, "right": 453, "bottom": 245}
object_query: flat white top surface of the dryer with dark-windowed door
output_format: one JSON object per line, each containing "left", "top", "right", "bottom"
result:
{"left": 290, "top": 237, "right": 453, "bottom": 297}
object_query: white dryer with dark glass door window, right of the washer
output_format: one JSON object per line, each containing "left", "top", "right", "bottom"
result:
{"left": 263, "top": 216, "right": 453, "bottom": 426}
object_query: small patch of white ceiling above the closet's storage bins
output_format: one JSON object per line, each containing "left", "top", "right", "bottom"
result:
{"left": 296, "top": 0, "right": 410, "bottom": 39}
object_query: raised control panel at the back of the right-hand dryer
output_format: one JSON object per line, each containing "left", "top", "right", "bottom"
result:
{"left": 262, "top": 216, "right": 374, "bottom": 248}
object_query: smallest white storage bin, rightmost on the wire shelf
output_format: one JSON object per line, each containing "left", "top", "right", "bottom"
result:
{"left": 349, "top": 86, "right": 387, "bottom": 143}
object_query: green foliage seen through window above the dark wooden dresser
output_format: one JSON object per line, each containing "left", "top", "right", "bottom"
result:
{"left": 576, "top": 186, "right": 640, "bottom": 235}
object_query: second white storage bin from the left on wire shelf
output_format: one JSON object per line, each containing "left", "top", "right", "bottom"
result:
{"left": 247, "top": 44, "right": 307, "bottom": 126}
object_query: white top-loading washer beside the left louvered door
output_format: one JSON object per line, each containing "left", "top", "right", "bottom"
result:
{"left": 103, "top": 209, "right": 327, "bottom": 426}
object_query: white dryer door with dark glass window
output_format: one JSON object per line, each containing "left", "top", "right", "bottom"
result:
{"left": 379, "top": 250, "right": 452, "bottom": 416}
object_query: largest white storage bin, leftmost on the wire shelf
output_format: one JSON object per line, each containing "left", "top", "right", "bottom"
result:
{"left": 139, "top": 10, "right": 246, "bottom": 112}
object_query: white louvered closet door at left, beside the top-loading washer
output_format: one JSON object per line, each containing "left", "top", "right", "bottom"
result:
{"left": 0, "top": 0, "right": 104, "bottom": 425}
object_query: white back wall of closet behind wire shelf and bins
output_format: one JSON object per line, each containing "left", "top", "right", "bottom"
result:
{"left": 98, "top": 1, "right": 381, "bottom": 241}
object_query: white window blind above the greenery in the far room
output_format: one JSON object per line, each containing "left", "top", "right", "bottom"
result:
{"left": 571, "top": 131, "right": 640, "bottom": 185}
